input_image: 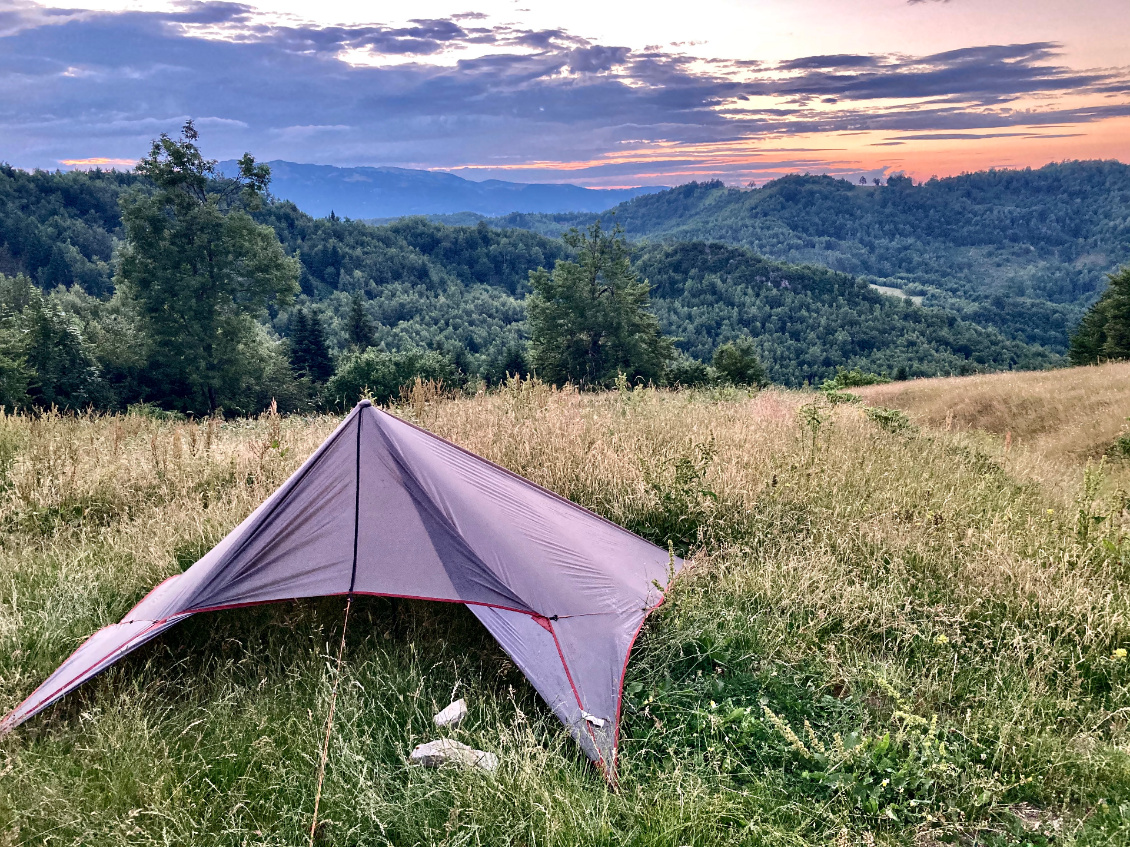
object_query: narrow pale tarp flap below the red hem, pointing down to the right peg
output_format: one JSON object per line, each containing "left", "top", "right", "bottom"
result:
{"left": 468, "top": 605, "right": 601, "bottom": 761}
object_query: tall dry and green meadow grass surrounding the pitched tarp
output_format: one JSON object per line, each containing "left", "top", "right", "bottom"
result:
{"left": 0, "top": 369, "right": 1130, "bottom": 847}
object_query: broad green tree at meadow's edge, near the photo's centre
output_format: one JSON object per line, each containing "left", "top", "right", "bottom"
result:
{"left": 525, "top": 220, "right": 675, "bottom": 387}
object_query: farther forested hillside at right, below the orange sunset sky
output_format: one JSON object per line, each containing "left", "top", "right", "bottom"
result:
{"left": 492, "top": 161, "right": 1130, "bottom": 352}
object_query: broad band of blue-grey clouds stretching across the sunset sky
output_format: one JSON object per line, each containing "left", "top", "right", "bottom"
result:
{"left": 0, "top": 2, "right": 1130, "bottom": 184}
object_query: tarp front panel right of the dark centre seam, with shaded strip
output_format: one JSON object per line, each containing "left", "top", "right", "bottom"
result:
{"left": 354, "top": 409, "right": 519, "bottom": 608}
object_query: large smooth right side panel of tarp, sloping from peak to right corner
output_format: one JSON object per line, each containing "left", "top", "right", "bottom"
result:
{"left": 372, "top": 410, "right": 681, "bottom": 618}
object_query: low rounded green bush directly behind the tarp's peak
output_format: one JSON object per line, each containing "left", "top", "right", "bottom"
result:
{"left": 325, "top": 347, "right": 459, "bottom": 409}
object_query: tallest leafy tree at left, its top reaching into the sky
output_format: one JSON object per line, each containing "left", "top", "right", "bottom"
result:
{"left": 115, "top": 121, "right": 298, "bottom": 413}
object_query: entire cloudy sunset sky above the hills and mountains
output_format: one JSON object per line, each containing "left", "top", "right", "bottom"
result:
{"left": 0, "top": 0, "right": 1130, "bottom": 187}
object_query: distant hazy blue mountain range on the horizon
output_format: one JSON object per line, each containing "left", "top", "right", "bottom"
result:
{"left": 219, "top": 160, "right": 663, "bottom": 219}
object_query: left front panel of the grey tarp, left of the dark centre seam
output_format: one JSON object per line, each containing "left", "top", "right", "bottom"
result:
{"left": 169, "top": 413, "right": 358, "bottom": 611}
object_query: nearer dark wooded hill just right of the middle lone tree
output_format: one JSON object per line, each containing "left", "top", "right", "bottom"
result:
{"left": 635, "top": 242, "right": 1058, "bottom": 385}
